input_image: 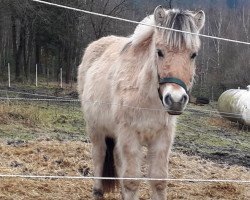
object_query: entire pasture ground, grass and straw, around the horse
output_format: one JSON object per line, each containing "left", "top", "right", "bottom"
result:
{"left": 0, "top": 88, "right": 250, "bottom": 200}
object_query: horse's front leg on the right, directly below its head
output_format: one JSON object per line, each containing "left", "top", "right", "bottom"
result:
{"left": 148, "top": 134, "right": 172, "bottom": 200}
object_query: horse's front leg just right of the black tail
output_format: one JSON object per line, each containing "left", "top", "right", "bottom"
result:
{"left": 117, "top": 131, "right": 142, "bottom": 200}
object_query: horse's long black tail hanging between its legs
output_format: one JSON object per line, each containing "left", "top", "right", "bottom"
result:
{"left": 102, "top": 137, "right": 118, "bottom": 193}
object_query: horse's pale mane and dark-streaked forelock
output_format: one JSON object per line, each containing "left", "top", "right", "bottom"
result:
{"left": 131, "top": 9, "right": 200, "bottom": 49}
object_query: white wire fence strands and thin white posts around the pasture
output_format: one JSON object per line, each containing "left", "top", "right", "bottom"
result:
{"left": 0, "top": 0, "right": 250, "bottom": 198}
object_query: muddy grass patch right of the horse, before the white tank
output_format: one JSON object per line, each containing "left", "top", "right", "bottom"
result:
{"left": 174, "top": 104, "right": 250, "bottom": 167}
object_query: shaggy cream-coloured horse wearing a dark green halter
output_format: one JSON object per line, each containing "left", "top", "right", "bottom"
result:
{"left": 77, "top": 6, "right": 205, "bottom": 200}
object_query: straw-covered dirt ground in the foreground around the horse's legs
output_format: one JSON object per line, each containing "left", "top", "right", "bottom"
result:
{"left": 0, "top": 141, "right": 250, "bottom": 200}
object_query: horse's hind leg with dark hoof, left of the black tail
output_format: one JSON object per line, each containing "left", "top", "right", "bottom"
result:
{"left": 89, "top": 127, "right": 106, "bottom": 200}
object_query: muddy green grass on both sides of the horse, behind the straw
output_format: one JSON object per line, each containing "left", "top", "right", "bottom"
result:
{"left": 0, "top": 97, "right": 250, "bottom": 167}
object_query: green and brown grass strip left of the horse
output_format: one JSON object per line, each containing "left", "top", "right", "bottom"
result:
{"left": 0, "top": 101, "right": 85, "bottom": 140}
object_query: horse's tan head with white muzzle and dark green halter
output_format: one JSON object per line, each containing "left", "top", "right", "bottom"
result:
{"left": 152, "top": 6, "right": 205, "bottom": 115}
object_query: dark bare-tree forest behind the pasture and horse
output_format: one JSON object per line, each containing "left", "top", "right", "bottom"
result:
{"left": 0, "top": 0, "right": 250, "bottom": 100}
